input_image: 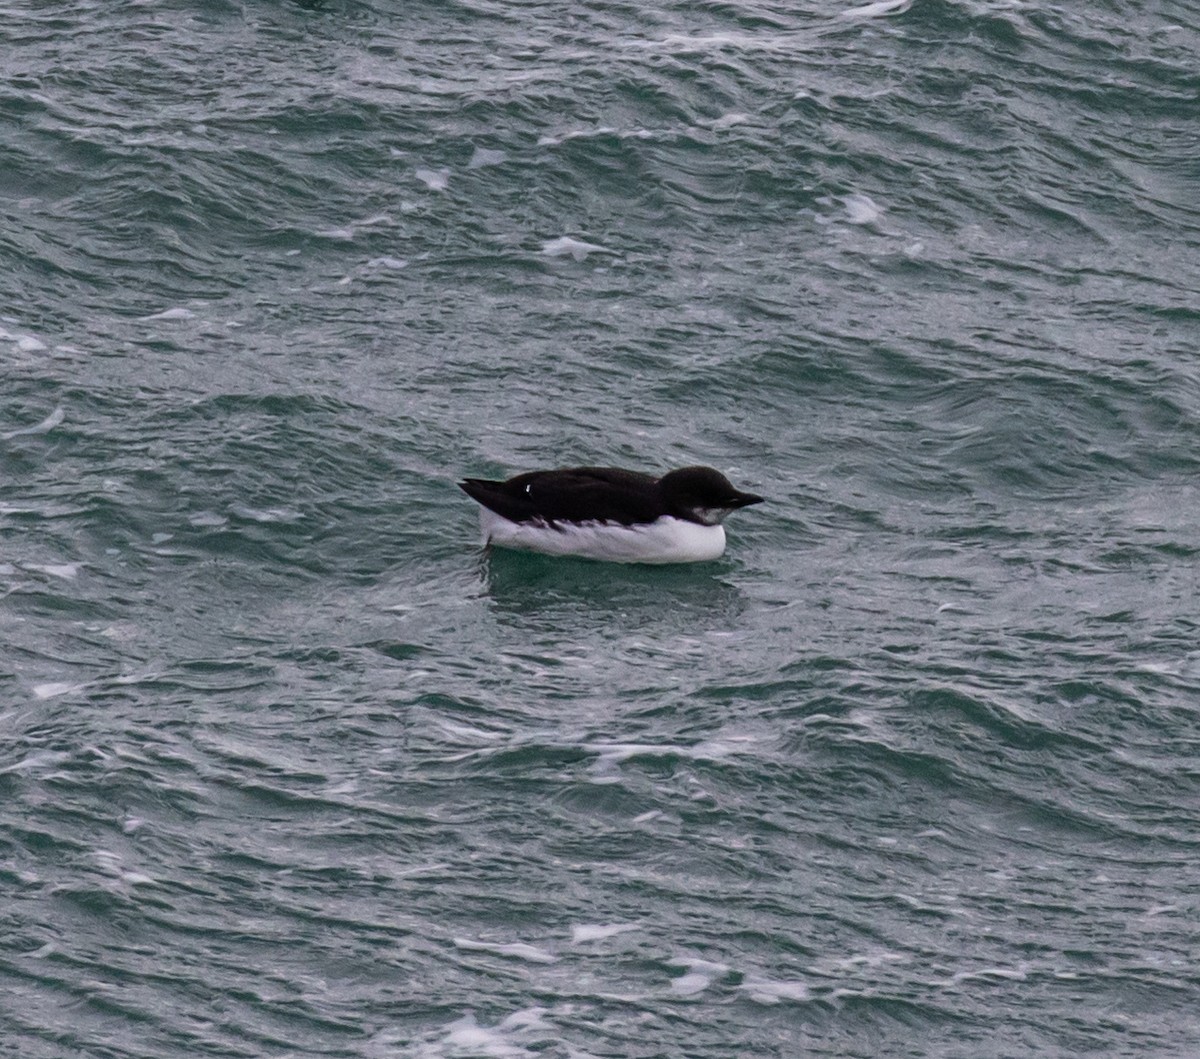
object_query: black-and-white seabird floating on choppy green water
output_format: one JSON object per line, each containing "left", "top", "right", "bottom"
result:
{"left": 458, "top": 467, "right": 763, "bottom": 563}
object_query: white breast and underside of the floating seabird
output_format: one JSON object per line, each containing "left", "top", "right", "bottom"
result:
{"left": 479, "top": 508, "right": 725, "bottom": 563}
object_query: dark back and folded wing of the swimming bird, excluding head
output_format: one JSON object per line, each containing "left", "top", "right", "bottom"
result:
{"left": 461, "top": 467, "right": 666, "bottom": 526}
